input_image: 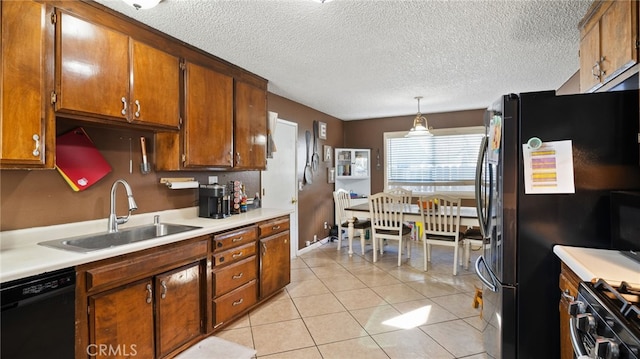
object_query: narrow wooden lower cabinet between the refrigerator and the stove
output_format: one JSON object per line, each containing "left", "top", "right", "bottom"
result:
{"left": 559, "top": 263, "right": 580, "bottom": 359}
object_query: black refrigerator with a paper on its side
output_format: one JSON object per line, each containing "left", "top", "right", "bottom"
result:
{"left": 475, "top": 90, "right": 640, "bottom": 359}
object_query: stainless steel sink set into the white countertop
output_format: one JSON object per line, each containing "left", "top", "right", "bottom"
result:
{"left": 38, "top": 223, "right": 202, "bottom": 253}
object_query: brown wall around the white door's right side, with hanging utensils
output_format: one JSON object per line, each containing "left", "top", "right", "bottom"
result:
{"left": 268, "top": 93, "right": 344, "bottom": 248}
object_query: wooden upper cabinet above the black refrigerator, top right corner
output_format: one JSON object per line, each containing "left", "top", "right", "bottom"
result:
{"left": 580, "top": 0, "right": 639, "bottom": 92}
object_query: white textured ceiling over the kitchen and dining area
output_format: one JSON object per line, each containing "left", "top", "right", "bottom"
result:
{"left": 97, "top": 0, "right": 592, "bottom": 120}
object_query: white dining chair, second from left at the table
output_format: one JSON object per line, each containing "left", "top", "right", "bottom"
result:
{"left": 369, "top": 192, "right": 411, "bottom": 266}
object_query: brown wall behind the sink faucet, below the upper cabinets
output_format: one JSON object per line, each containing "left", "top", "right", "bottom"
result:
{"left": 0, "top": 119, "right": 260, "bottom": 231}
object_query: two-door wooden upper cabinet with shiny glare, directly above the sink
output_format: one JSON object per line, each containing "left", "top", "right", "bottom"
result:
{"left": 56, "top": 12, "right": 180, "bottom": 129}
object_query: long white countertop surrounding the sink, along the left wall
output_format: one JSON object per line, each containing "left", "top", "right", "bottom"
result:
{"left": 0, "top": 207, "right": 291, "bottom": 283}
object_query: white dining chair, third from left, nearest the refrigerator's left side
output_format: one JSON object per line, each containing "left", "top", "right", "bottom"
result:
{"left": 418, "top": 194, "right": 466, "bottom": 275}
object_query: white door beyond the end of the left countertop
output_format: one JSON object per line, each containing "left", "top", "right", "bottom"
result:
{"left": 261, "top": 119, "right": 298, "bottom": 258}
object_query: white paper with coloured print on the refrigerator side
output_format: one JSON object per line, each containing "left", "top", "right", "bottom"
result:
{"left": 522, "top": 140, "right": 576, "bottom": 194}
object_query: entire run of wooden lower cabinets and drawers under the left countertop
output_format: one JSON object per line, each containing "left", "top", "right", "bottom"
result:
{"left": 75, "top": 216, "right": 291, "bottom": 359}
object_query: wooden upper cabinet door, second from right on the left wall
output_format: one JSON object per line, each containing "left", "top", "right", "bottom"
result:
{"left": 184, "top": 63, "right": 233, "bottom": 167}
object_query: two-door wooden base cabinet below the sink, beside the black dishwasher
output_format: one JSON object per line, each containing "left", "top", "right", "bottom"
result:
{"left": 76, "top": 236, "right": 209, "bottom": 358}
